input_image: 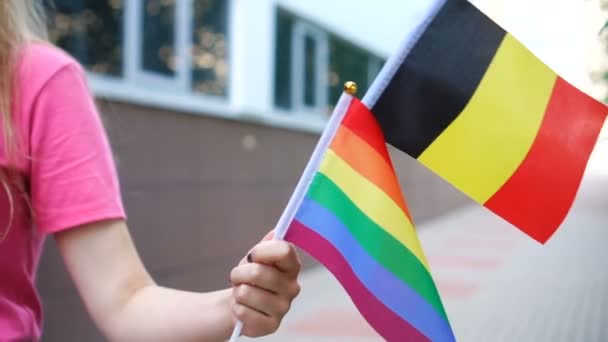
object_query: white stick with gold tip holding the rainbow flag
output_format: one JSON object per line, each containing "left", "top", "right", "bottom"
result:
{"left": 229, "top": 82, "right": 357, "bottom": 342}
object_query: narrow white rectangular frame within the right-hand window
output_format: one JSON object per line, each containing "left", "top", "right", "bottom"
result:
{"left": 291, "top": 19, "right": 329, "bottom": 115}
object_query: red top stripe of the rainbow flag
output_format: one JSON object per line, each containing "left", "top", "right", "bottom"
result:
{"left": 342, "top": 98, "right": 414, "bottom": 223}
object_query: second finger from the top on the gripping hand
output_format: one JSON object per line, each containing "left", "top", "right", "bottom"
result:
{"left": 230, "top": 263, "right": 289, "bottom": 294}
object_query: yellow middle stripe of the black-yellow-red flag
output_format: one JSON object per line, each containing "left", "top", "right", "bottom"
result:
{"left": 418, "top": 34, "right": 556, "bottom": 204}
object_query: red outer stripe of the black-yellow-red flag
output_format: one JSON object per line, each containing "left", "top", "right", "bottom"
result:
{"left": 485, "top": 78, "right": 608, "bottom": 243}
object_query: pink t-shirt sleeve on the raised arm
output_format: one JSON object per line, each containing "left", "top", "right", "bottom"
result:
{"left": 30, "top": 63, "right": 126, "bottom": 233}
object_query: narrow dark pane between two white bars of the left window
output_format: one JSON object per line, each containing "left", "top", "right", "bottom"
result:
{"left": 142, "top": 0, "right": 175, "bottom": 76}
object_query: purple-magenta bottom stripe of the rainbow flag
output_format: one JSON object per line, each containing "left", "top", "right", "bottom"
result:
{"left": 285, "top": 220, "right": 429, "bottom": 342}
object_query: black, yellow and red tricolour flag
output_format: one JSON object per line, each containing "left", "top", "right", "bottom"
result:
{"left": 363, "top": 0, "right": 608, "bottom": 243}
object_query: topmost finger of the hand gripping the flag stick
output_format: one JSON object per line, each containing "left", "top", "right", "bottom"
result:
{"left": 250, "top": 240, "right": 301, "bottom": 275}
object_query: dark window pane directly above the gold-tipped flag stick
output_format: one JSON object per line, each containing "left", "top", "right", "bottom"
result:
{"left": 328, "top": 37, "right": 370, "bottom": 107}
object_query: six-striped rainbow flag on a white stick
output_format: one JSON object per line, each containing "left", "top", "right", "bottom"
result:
{"left": 279, "top": 93, "right": 455, "bottom": 341}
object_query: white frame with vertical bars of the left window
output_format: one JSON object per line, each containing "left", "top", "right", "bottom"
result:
{"left": 87, "top": 0, "right": 237, "bottom": 117}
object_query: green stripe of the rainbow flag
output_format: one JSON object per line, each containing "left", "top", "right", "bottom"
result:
{"left": 307, "top": 173, "right": 447, "bottom": 320}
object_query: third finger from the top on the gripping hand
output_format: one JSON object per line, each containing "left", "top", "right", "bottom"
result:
{"left": 232, "top": 284, "right": 291, "bottom": 317}
